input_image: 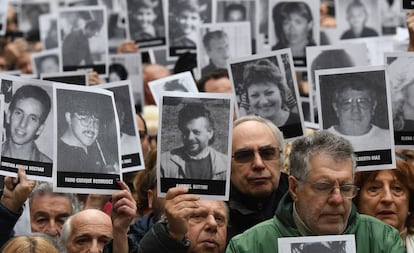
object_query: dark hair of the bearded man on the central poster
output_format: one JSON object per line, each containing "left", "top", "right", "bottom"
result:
{"left": 178, "top": 103, "right": 214, "bottom": 144}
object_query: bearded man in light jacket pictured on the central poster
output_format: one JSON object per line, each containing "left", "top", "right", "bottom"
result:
{"left": 160, "top": 104, "right": 227, "bottom": 180}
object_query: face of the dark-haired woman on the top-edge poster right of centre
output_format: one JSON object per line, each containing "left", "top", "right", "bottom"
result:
{"left": 282, "top": 13, "right": 312, "bottom": 45}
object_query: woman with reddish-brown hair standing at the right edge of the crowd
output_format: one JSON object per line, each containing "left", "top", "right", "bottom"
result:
{"left": 354, "top": 160, "right": 414, "bottom": 250}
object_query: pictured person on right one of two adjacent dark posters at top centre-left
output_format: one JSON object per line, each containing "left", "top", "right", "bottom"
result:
{"left": 171, "top": 0, "right": 207, "bottom": 47}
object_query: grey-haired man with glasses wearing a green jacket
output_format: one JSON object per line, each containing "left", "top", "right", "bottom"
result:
{"left": 226, "top": 130, "right": 406, "bottom": 253}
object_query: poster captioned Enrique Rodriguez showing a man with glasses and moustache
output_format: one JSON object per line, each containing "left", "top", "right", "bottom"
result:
{"left": 53, "top": 83, "right": 122, "bottom": 194}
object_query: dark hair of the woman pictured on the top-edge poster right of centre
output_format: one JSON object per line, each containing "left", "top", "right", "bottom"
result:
{"left": 272, "top": 2, "right": 315, "bottom": 48}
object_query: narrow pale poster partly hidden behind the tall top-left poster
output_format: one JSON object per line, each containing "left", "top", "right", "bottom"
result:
{"left": 39, "top": 13, "right": 59, "bottom": 50}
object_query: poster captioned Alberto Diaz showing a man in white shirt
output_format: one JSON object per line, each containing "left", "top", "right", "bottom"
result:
{"left": 315, "top": 65, "right": 395, "bottom": 171}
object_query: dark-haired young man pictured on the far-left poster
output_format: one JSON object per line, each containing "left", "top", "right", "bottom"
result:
{"left": 1, "top": 85, "right": 52, "bottom": 163}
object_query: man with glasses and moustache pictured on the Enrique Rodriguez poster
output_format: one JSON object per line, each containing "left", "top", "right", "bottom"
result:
{"left": 57, "top": 94, "right": 113, "bottom": 173}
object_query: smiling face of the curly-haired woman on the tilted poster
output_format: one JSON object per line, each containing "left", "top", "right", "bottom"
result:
{"left": 247, "top": 82, "right": 282, "bottom": 118}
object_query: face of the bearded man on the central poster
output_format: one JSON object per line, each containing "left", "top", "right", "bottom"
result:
{"left": 181, "top": 117, "right": 214, "bottom": 155}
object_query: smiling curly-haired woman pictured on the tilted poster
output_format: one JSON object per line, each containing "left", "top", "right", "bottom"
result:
{"left": 242, "top": 59, "right": 300, "bottom": 137}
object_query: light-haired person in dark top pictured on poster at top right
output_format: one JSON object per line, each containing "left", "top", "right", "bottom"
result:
{"left": 341, "top": 0, "right": 378, "bottom": 39}
